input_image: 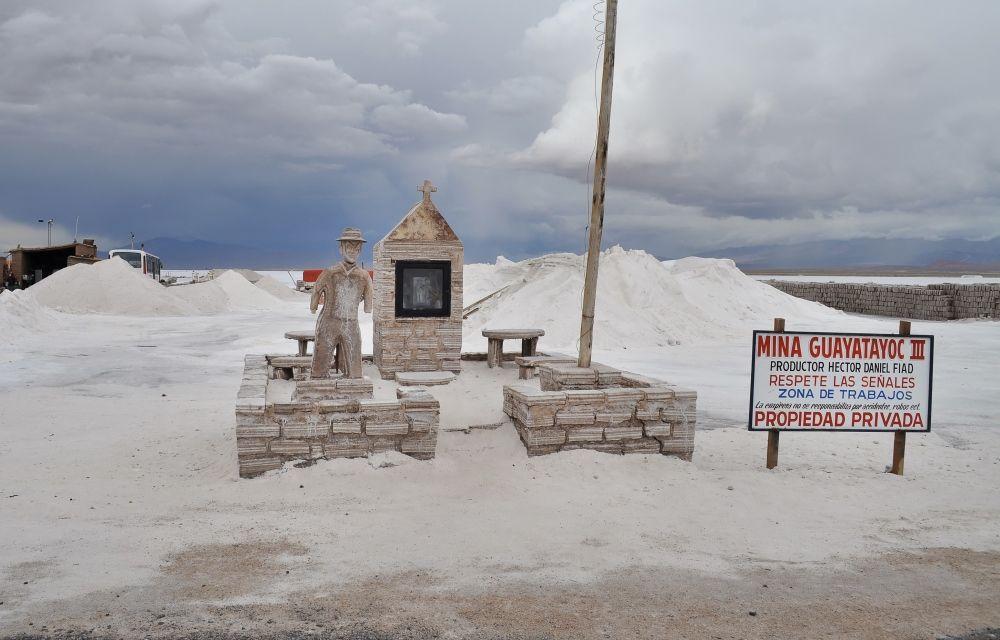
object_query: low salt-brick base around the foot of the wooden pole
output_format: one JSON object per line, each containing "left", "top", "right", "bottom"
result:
{"left": 504, "top": 363, "right": 697, "bottom": 460}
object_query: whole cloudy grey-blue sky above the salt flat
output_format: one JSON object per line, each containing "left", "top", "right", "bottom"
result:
{"left": 0, "top": 0, "right": 1000, "bottom": 266}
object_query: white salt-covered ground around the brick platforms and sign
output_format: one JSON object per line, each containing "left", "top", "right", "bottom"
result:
{"left": 0, "top": 250, "right": 1000, "bottom": 616}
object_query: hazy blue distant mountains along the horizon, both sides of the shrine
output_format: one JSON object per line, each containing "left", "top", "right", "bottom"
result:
{"left": 121, "top": 238, "right": 1000, "bottom": 273}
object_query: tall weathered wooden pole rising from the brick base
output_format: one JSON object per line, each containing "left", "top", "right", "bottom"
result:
{"left": 577, "top": 0, "right": 618, "bottom": 367}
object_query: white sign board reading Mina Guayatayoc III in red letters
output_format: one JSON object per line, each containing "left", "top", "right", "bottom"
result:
{"left": 750, "top": 331, "right": 934, "bottom": 431}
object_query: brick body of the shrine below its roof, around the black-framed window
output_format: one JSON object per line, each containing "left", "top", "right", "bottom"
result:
{"left": 372, "top": 240, "right": 463, "bottom": 380}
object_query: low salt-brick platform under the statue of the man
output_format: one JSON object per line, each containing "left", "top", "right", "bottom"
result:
{"left": 236, "top": 355, "right": 440, "bottom": 478}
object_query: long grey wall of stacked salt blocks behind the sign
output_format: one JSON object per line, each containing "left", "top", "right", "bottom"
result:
{"left": 767, "top": 280, "right": 1000, "bottom": 320}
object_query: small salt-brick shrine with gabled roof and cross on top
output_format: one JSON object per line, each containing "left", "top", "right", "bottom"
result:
{"left": 372, "top": 181, "right": 464, "bottom": 380}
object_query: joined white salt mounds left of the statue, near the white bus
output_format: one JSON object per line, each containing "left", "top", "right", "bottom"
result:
{"left": 23, "top": 258, "right": 304, "bottom": 316}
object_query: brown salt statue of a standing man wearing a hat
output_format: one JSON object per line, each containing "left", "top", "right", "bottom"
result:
{"left": 309, "top": 227, "right": 372, "bottom": 378}
